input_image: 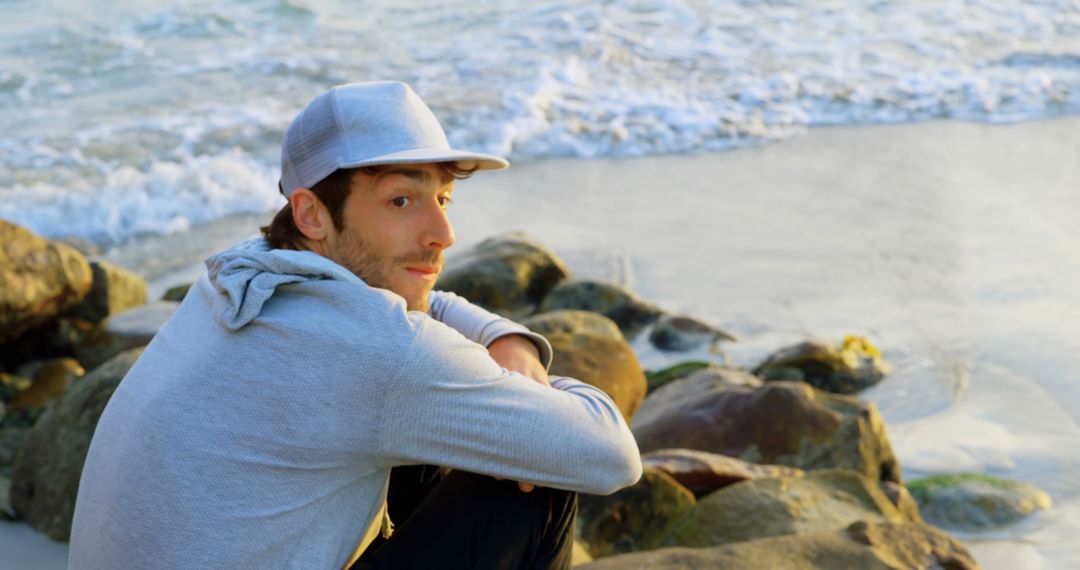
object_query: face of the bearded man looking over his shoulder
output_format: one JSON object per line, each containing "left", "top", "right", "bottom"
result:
{"left": 326, "top": 164, "right": 454, "bottom": 312}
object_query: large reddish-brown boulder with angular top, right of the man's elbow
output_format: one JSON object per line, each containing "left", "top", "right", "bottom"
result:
{"left": 634, "top": 375, "right": 900, "bottom": 483}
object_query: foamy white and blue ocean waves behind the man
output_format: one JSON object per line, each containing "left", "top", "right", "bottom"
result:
{"left": 0, "top": 0, "right": 1080, "bottom": 245}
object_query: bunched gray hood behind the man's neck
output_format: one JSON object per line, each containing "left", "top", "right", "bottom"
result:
{"left": 206, "top": 238, "right": 364, "bottom": 330}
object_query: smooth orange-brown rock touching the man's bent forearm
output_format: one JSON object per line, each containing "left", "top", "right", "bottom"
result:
{"left": 548, "top": 334, "right": 646, "bottom": 423}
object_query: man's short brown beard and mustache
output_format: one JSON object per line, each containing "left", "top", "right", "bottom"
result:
{"left": 330, "top": 224, "right": 443, "bottom": 313}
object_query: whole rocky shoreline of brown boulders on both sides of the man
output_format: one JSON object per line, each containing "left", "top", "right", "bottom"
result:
{"left": 0, "top": 221, "right": 1050, "bottom": 568}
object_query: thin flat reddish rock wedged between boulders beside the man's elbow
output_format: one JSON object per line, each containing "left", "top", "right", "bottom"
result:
{"left": 642, "top": 449, "right": 804, "bottom": 499}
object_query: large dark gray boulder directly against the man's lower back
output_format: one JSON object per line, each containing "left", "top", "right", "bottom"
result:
{"left": 11, "top": 349, "right": 143, "bottom": 541}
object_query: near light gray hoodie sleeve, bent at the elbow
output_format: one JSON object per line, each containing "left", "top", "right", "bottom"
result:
{"left": 378, "top": 318, "right": 642, "bottom": 494}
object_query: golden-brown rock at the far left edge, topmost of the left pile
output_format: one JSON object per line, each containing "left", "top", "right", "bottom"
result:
{"left": 0, "top": 219, "right": 92, "bottom": 342}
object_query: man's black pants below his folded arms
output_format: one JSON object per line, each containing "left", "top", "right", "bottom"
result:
{"left": 353, "top": 465, "right": 578, "bottom": 570}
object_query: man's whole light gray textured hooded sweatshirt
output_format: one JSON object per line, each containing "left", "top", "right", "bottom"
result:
{"left": 69, "top": 240, "right": 640, "bottom": 570}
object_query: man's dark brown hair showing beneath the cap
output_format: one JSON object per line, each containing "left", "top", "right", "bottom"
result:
{"left": 259, "top": 162, "right": 476, "bottom": 249}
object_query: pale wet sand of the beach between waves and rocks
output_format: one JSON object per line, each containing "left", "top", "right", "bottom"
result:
{"left": 0, "top": 118, "right": 1080, "bottom": 570}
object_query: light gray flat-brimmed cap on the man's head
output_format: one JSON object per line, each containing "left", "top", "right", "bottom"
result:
{"left": 281, "top": 81, "right": 510, "bottom": 198}
